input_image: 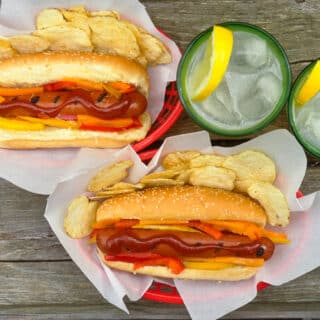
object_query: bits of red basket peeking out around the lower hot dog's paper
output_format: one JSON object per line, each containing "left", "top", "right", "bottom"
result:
{"left": 139, "top": 149, "right": 303, "bottom": 304}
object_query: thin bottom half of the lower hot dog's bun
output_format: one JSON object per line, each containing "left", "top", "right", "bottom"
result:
{"left": 98, "top": 249, "right": 259, "bottom": 281}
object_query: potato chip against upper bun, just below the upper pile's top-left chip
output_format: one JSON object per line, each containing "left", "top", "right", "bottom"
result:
{"left": 33, "top": 26, "right": 93, "bottom": 51}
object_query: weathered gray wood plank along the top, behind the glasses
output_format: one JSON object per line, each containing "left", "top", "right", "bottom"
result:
{"left": 142, "top": 0, "right": 320, "bottom": 62}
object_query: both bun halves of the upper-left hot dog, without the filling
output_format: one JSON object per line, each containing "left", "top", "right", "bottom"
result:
{"left": 0, "top": 52, "right": 151, "bottom": 149}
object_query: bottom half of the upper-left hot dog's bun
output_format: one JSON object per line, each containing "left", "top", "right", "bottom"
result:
{"left": 0, "top": 113, "right": 151, "bottom": 149}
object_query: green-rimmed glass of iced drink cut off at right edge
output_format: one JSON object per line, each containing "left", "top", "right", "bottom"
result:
{"left": 288, "top": 61, "right": 320, "bottom": 157}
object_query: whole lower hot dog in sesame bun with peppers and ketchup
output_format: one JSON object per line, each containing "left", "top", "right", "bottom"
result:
{"left": 92, "top": 185, "right": 288, "bottom": 281}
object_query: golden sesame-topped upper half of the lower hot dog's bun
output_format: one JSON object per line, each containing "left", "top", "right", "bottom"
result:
{"left": 97, "top": 185, "right": 266, "bottom": 226}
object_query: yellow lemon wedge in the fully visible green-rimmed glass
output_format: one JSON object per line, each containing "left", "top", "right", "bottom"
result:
{"left": 191, "top": 26, "right": 233, "bottom": 101}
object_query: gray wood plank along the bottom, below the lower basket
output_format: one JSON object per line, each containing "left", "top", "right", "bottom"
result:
{"left": 0, "top": 261, "right": 320, "bottom": 319}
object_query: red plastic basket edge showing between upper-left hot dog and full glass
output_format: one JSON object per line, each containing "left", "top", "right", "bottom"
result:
{"left": 132, "top": 81, "right": 183, "bottom": 152}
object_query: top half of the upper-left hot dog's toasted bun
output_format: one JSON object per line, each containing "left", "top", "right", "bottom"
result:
{"left": 0, "top": 52, "right": 149, "bottom": 96}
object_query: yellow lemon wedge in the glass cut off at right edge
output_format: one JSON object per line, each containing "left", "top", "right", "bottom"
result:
{"left": 296, "top": 60, "right": 320, "bottom": 106}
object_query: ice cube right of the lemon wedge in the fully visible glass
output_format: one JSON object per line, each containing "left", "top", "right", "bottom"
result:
{"left": 229, "top": 31, "right": 272, "bottom": 73}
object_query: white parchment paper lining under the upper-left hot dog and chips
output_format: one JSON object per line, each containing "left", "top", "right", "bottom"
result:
{"left": 0, "top": 0, "right": 181, "bottom": 194}
